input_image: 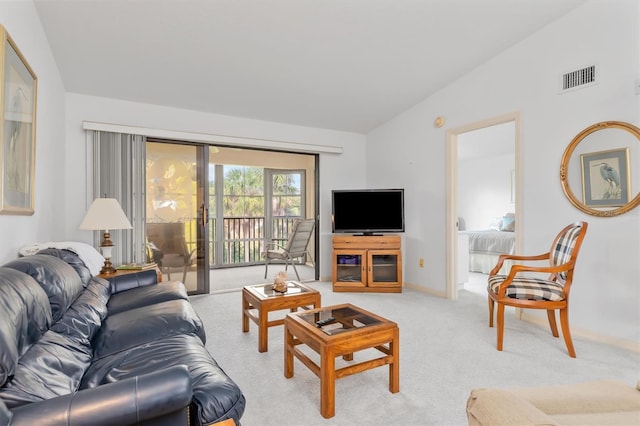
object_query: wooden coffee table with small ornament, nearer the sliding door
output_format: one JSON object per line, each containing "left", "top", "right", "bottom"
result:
{"left": 242, "top": 281, "right": 321, "bottom": 352}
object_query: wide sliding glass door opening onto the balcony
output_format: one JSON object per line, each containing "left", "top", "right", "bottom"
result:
{"left": 145, "top": 139, "right": 317, "bottom": 294}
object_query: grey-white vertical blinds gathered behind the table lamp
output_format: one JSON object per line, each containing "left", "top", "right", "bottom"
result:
{"left": 90, "top": 131, "right": 147, "bottom": 266}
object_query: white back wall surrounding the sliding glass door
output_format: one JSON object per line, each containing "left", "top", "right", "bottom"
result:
{"left": 65, "top": 93, "right": 365, "bottom": 279}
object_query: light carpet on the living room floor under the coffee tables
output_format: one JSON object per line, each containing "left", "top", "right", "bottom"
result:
{"left": 192, "top": 282, "right": 640, "bottom": 426}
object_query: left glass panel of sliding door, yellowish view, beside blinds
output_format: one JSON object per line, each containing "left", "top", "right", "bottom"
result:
{"left": 145, "top": 140, "right": 209, "bottom": 294}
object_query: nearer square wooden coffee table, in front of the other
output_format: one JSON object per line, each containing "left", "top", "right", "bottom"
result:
{"left": 284, "top": 303, "right": 400, "bottom": 418}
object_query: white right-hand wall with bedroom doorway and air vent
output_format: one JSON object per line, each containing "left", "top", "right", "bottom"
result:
{"left": 367, "top": 0, "right": 640, "bottom": 344}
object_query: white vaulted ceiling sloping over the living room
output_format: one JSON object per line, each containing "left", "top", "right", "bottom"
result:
{"left": 35, "top": 0, "right": 584, "bottom": 133}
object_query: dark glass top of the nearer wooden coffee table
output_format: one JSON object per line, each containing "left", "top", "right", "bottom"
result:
{"left": 297, "top": 307, "right": 382, "bottom": 335}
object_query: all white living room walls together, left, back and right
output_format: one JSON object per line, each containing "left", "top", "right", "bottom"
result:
{"left": 0, "top": 0, "right": 640, "bottom": 350}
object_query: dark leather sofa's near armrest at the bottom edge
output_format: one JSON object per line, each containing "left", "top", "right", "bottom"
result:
{"left": 11, "top": 365, "right": 192, "bottom": 426}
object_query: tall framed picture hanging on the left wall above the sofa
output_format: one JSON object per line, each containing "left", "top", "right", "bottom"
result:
{"left": 0, "top": 25, "right": 38, "bottom": 215}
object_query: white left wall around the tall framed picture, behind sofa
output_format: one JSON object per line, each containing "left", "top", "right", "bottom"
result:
{"left": 0, "top": 1, "right": 65, "bottom": 263}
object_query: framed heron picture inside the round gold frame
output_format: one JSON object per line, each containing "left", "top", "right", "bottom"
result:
{"left": 580, "top": 147, "right": 631, "bottom": 207}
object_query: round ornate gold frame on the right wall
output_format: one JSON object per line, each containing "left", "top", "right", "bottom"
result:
{"left": 560, "top": 121, "right": 640, "bottom": 217}
